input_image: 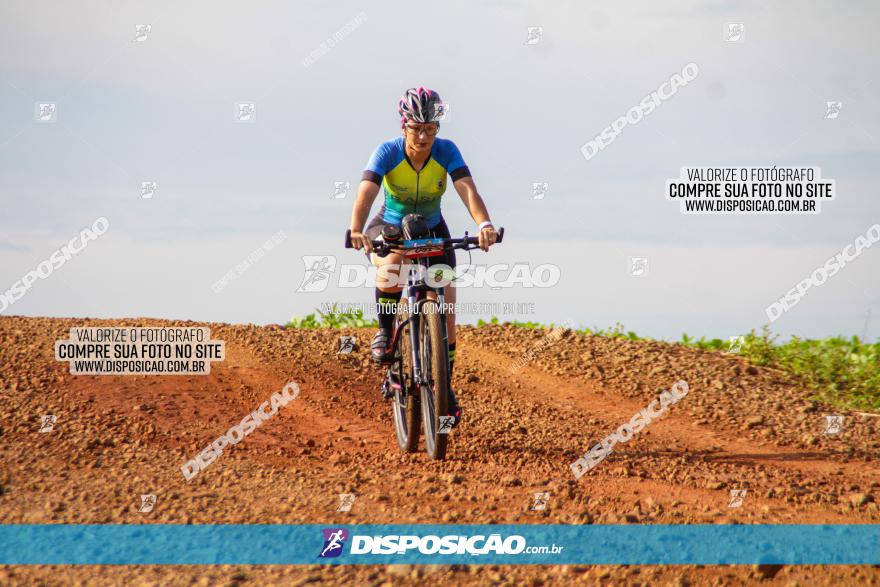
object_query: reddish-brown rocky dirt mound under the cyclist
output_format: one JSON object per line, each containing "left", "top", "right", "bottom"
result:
{"left": 0, "top": 317, "right": 880, "bottom": 585}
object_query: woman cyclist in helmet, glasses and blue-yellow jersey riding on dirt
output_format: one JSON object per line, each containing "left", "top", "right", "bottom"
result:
{"left": 349, "top": 87, "right": 498, "bottom": 426}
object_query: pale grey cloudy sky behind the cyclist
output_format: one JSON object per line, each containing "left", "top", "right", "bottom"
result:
{"left": 0, "top": 0, "right": 880, "bottom": 340}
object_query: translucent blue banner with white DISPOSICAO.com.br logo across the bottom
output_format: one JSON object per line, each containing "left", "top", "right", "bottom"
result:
{"left": 0, "top": 524, "right": 880, "bottom": 565}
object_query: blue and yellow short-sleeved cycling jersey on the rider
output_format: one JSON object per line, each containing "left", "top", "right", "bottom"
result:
{"left": 363, "top": 136, "right": 471, "bottom": 228}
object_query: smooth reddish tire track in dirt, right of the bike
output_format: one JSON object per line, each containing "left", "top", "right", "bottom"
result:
{"left": 467, "top": 347, "right": 880, "bottom": 523}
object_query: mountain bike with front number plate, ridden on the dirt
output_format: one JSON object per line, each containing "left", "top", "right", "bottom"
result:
{"left": 345, "top": 220, "right": 504, "bottom": 460}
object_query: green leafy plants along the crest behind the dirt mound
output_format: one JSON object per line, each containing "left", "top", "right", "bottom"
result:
{"left": 287, "top": 306, "right": 880, "bottom": 411}
